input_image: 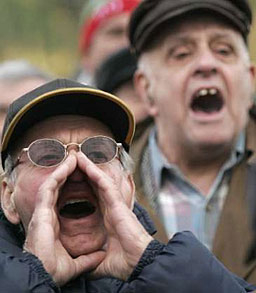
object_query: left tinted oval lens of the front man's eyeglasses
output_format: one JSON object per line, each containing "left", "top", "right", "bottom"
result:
{"left": 28, "top": 139, "right": 65, "bottom": 167}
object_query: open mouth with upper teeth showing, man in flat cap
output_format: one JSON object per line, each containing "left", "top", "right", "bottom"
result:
{"left": 190, "top": 88, "right": 224, "bottom": 114}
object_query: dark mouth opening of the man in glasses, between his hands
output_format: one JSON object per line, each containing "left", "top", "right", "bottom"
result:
{"left": 60, "top": 201, "right": 96, "bottom": 219}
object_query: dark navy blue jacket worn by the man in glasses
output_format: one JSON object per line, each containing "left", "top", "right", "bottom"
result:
{"left": 0, "top": 206, "right": 256, "bottom": 293}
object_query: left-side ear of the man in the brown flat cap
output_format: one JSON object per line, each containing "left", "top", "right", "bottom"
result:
{"left": 133, "top": 69, "right": 157, "bottom": 117}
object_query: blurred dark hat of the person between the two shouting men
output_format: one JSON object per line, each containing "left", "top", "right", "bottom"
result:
{"left": 95, "top": 48, "right": 137, "bottom": 93}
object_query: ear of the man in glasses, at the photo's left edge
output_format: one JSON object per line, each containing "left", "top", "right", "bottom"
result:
{"left": 1, "top": 179, "right": 20, "bottom": 224}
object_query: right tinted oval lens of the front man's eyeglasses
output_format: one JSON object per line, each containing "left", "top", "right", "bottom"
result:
{"left": 81, "top": 137, "right": 117, "bottom": 164}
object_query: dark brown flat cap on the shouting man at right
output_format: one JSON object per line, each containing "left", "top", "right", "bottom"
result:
{"left": 129, "top": 0, "right": 252, "bottom": 55}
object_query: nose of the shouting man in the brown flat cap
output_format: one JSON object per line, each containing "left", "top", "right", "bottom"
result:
{"left": 194, "top": 49, "right": 218, "bottom": 78}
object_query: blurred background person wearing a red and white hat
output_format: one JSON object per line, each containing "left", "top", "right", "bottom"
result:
{"left": 76, "top": 0, "right": 140, "bottom": 85}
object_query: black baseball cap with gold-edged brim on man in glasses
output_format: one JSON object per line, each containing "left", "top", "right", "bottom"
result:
{"left": 1, "top": 79, "right": 135, "bottom": 167}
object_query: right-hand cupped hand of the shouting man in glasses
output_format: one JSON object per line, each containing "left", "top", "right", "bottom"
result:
{"left": 77, "top": 153, "right": 153, "bottom": 280}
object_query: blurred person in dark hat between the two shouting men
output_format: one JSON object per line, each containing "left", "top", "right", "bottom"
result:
{"left": 95, "top": 48, "right": 153, "bottom": 154}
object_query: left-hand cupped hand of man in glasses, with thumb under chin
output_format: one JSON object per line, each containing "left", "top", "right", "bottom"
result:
{"left": 24, "top": 154, "right": 105, "bottom": 286}
